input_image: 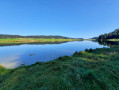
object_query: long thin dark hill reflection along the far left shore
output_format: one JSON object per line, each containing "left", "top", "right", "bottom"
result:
{"left": 0, "top": 41, "right": 68, "bottom": 47}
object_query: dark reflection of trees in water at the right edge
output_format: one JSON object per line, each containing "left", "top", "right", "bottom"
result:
{"left": 98, "top": 41, "right": 119, "bottom": 47}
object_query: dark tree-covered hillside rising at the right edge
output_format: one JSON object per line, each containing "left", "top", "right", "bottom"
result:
{"left": 98, "top": 29, "right": 119, "bottom": 40}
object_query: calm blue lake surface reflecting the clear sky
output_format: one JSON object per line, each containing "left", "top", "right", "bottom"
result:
{"left": 0, "top": 41, "right": 105, "bottom": 68}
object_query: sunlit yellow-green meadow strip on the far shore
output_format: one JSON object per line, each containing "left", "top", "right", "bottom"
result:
{"left": 0, "top": 38, "right": 81, "bottom": 44}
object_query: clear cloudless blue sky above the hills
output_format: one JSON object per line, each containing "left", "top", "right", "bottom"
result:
{"left": 0, "top": 0, "right": 119, "bottom": 38}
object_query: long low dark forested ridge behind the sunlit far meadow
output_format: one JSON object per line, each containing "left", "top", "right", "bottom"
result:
{"left": 0, "top": 34, "right": 72, "bottom": 39}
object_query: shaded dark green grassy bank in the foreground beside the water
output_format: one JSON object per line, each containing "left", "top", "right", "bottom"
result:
{"left": 0, "top": 48, "right": 119, "bottom": 90}
